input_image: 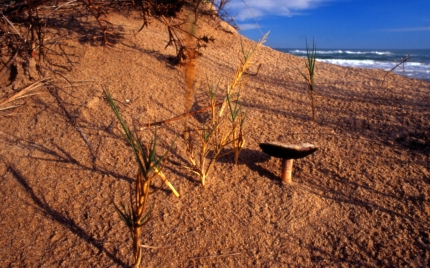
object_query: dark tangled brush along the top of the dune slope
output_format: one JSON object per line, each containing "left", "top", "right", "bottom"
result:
{"left": 0, "top": 0, "right": 235, "bottom": 79}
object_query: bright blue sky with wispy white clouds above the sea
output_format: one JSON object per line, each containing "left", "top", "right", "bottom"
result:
{"left": 229, "top": 0, "right": 430, "bottom": 49}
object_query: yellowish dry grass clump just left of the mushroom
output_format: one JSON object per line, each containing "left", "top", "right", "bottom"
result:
{"left": 181, "top": 35, "right": 267, "bottom": 185}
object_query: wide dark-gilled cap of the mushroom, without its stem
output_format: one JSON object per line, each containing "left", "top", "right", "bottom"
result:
{"left": 260, "top": 142, "right": 318, "bottom": 159}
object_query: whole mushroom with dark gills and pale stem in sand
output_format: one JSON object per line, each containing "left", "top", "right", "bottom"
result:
{"left": 260, "top": 142, "right": 318, "bottom": 184}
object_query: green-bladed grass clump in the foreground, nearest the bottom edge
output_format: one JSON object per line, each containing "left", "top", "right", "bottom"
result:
{"left": 106, "top": 89, "right": 179, "bottom": 267}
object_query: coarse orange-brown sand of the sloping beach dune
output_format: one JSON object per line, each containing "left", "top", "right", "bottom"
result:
{"left": 0, "top": 9, "right": 430, "bottom": 267}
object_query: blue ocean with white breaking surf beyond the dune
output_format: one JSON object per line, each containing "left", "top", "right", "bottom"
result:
{"left": 276, "top": 48, "right": 430, "bottom": 82}
